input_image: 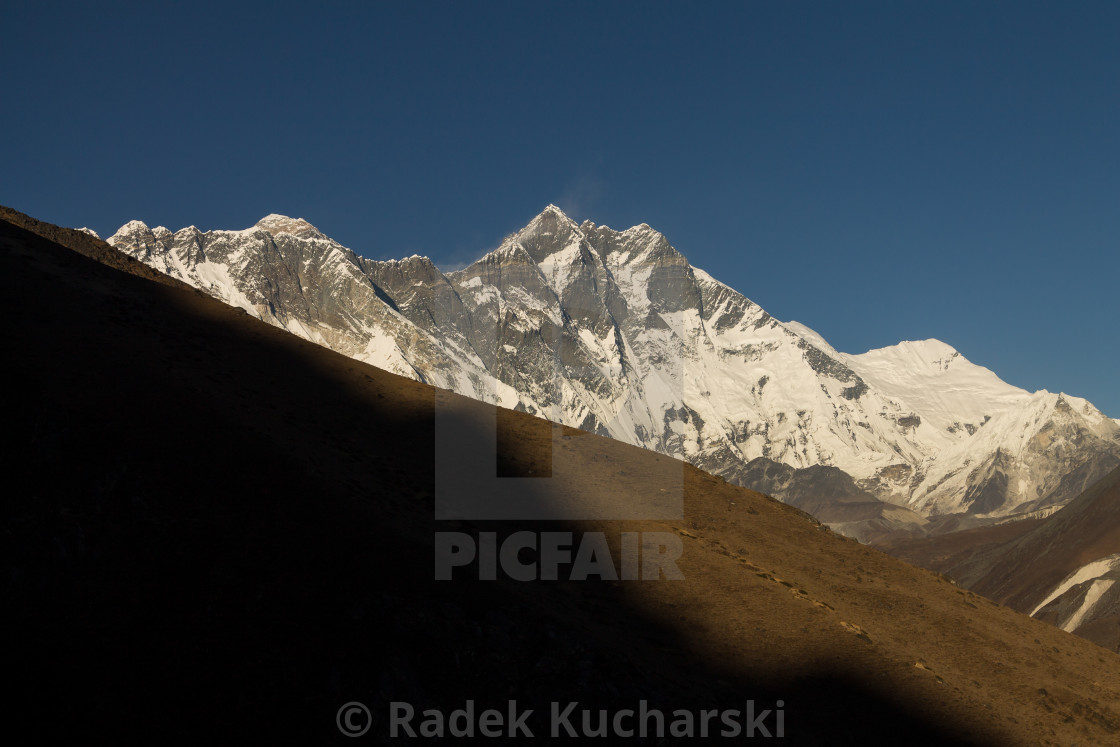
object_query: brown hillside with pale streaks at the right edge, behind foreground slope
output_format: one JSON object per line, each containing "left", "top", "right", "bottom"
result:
{"left": 884, "top": 468, "right": 1120, "bottom": 652}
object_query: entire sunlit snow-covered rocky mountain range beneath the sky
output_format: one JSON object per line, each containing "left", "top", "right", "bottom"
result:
{"left": 109, "top": 206, "right": 1120, "bottom": 536}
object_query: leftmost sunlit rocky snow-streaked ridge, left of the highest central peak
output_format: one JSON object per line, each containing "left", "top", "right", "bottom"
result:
{"left": 109, "top": 215, "right": 516, "bottom": 404}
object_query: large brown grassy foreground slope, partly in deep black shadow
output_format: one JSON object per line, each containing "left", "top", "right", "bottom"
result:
{"left": 0, "top": 206, "right": 1120, "bottom": 745}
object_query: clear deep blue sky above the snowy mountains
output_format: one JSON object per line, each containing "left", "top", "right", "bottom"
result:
{"left": 0, "top": 0, "right": 1120, "bottom": 417}
